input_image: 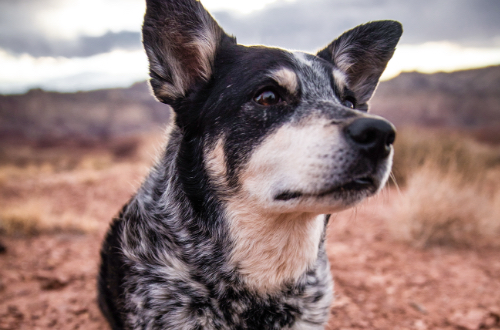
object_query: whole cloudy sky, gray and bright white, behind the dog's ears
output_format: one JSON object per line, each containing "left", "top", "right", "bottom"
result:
{"left": 0, "top": 0, "right": 500, "bottom": 94}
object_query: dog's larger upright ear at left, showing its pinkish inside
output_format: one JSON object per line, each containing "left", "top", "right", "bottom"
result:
{"left": 142, "top": 0, "right": 234, "bottom": 104}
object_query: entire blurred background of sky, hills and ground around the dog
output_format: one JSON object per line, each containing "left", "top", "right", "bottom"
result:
{"left": 0, "top": 0, "right": 500, "bottom": 330}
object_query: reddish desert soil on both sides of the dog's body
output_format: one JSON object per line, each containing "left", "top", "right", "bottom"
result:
{"left": 0, "top": 151, "right": 500, "bottom": 330}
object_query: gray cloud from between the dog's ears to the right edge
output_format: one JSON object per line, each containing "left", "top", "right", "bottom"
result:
{"left": 214, "top": 0, "right": 500, "bottom": 50}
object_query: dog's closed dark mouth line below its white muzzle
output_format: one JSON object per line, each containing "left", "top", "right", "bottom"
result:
{"left": 274, "top": 177, "right": 377, "bottom": 201}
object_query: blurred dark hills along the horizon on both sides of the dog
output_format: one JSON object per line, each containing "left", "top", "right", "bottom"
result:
{"left": 0, "top": 66, "right": 500, "bottom": 139}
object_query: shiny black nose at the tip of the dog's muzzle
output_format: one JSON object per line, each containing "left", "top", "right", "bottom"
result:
{"left": 345, "top": 118, "right": 396, "bottom": 160}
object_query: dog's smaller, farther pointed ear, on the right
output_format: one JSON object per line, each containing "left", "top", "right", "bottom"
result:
{"left": 317, "top": 21, "right": 403, "bottom": 104}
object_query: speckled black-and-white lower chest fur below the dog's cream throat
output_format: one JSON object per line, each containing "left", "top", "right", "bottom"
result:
{"left": 122, "top": 251, "right": 332, "bottom": 330}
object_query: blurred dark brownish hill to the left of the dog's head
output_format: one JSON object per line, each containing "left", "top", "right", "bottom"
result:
{"left": 0, "top": 82, "right": 170, "bottom": 140}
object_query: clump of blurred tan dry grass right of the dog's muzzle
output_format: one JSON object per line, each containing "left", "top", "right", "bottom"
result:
{"left": 383, "top": 130, "right": 500, "bottom": 247}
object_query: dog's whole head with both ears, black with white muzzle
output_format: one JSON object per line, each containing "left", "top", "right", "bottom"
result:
{"left": 143, "top": 0, "right": 402, "bottom": 214}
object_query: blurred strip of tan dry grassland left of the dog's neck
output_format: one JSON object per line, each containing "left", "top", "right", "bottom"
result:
{"left": 0, "top": 135, "right": 161, "bottom": 236}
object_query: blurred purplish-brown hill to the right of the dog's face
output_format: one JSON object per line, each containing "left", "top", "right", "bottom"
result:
{"left": 371, "top": 66, "right": 500, "bottom": 129}
